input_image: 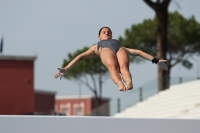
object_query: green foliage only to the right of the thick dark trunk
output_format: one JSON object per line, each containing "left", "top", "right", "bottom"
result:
{"left": 168, "top": 12, "right": 200, "bottom": 68}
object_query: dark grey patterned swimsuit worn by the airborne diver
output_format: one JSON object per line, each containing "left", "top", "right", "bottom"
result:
{"left": 97, "top": 39, "right": 122, "bottom": 53}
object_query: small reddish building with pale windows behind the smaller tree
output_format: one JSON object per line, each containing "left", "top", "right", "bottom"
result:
{"left": 55, "top": 95, "right": 109, "bottom": 116}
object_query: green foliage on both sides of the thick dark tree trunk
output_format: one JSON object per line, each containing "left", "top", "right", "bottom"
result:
{"left": 119, "top": 12, "right": 200, "bottom": 90}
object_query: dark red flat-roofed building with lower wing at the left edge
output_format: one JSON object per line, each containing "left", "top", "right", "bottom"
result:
{"left": 0, "top": 55, "right": 55, "bottom": 115}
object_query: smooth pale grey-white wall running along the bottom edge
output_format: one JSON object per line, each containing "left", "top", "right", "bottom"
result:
{"left": 0, "top": 116, "right": 200, "bottom": 133}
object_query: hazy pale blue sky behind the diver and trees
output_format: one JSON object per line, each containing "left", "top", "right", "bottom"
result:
{"left": 0, "top": 0, "right": 200, "bottom": 97}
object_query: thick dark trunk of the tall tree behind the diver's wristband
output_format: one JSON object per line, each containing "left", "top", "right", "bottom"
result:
{"left": 144, "top": 0, "right": 171, "bottom": 90}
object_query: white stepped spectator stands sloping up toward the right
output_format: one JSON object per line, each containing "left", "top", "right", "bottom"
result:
{"left": 114, "top": 80, "right": 200, "bottom": 119}
